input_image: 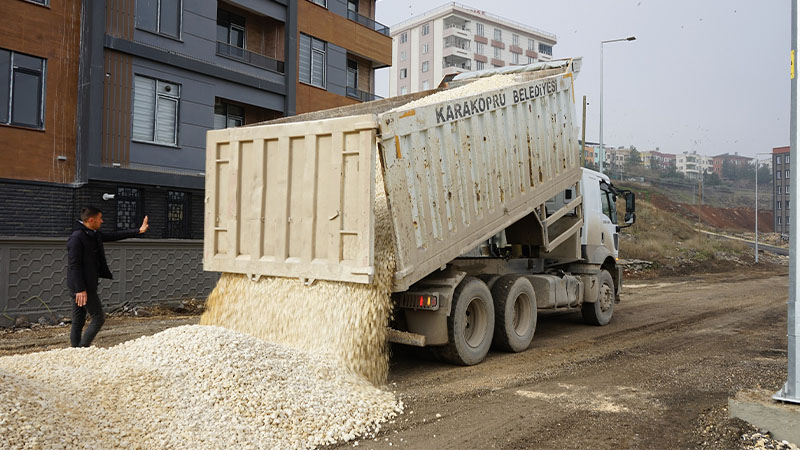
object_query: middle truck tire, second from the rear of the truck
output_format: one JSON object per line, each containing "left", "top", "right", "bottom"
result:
{"left": 492, "top": 275, "right": 537, "bottom": 352}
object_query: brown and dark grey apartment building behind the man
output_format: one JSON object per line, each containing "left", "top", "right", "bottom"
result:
{"left": 0, "top": 0, "right": 392, "bottom": 239}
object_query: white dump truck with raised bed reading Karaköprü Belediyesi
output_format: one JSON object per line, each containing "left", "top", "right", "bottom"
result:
{"left": 203, "top": 58, "right": 635, "bottom": 365}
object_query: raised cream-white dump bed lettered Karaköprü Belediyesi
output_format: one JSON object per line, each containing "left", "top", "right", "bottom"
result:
{"left": 203, "top": 60, "right": 581, "bottom": 292}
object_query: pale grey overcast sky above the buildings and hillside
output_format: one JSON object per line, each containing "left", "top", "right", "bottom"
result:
{"left": 376, "top": 0, "right": 791, "bottom": 158}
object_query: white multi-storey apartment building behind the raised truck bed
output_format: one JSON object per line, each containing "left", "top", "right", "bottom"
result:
{"left": 389, "top": 2, "right": 557, "bottom": 96}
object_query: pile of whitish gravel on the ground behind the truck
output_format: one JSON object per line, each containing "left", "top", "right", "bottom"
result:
{"left": 0, "top": 325, "right": 402, "bottom": 449}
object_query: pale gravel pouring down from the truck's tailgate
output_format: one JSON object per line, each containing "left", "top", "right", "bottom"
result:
{"left": 200, "top": 162, "right": 395, "bottom": 385}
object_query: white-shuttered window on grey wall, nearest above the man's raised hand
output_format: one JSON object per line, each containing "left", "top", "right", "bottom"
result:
{"left": 133, "top": 75, "right": 181, "bottom": 145}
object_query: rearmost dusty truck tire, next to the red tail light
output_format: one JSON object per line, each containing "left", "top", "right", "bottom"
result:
{"left": 439, "top": 277, "right": 494, "bottom": 366}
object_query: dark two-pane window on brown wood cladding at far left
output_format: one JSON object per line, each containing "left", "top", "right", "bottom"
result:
{"left": 0, "top": 49, "right": 47, "bottom": 129}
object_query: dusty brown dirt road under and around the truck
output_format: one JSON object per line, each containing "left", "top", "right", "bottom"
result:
{"left": 0, "top": 268, "right": 788, "bottom": 449}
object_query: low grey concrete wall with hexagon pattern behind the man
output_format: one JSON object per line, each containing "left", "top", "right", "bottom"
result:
{"left": 0, "top": 237, "right": 218, "bottom": 327}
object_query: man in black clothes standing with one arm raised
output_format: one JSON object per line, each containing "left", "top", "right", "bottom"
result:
{"left": 67, "top": 206, "right": 150, "bottom": 347}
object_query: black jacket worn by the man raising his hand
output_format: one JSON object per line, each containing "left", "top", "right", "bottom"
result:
{"left": 67, "top": 222, "right": 139, "bottom": 294}
